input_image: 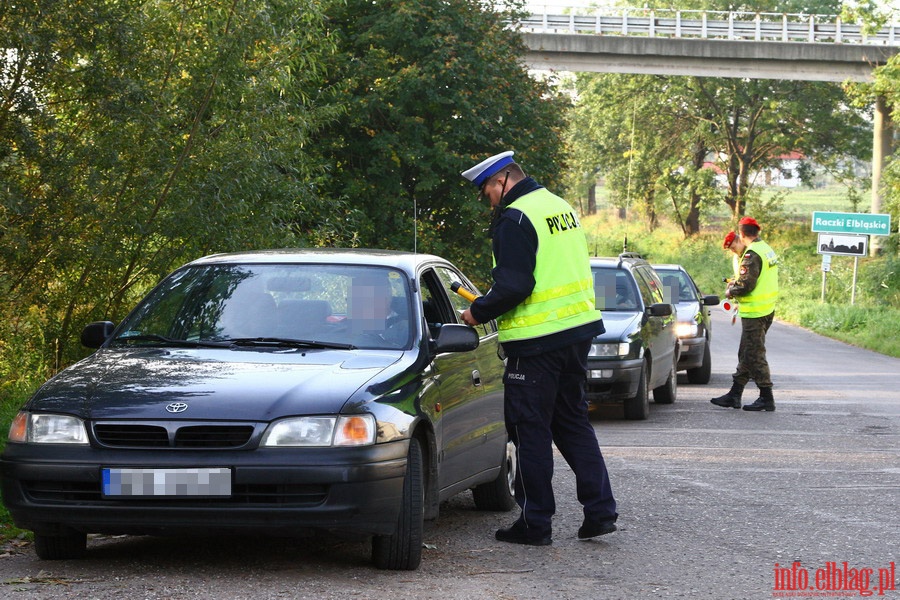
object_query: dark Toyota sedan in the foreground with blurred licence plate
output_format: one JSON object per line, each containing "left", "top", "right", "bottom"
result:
{"left": 0, "top": 249, "right": 515, "bottom": 569}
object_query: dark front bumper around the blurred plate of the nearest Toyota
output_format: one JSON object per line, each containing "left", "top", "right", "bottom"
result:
{"left": 0, "top": 440, "right": 409, "bottom": 535}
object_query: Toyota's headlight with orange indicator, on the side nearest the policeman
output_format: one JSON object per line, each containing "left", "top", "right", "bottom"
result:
{"left": 262, "top": 414, "right": 376, "bottom": 447}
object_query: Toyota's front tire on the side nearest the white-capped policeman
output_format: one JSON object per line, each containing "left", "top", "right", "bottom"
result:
{"left": 372, "top": 438, "right": 425, "bottom": 571}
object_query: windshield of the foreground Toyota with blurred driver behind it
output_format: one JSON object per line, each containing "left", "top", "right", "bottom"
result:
{"left": 111, "top": 264, "right": 411, "bottom": 349}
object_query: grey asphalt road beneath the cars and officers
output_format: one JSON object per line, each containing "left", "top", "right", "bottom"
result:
{"left": 0, "top": 313, "right": 900, "bottom": 600}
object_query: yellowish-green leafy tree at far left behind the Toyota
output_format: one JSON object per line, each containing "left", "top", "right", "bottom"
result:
{"left": 0, "top": 0, "right": 338, "bottom": 392}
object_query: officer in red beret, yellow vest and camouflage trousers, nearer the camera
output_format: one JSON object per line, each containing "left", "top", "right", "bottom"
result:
{"left": 710, "top": 217, "right": 778, "bottom": 412}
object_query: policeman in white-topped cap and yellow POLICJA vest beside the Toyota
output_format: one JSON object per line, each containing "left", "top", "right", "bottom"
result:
{"left": 462, "top": 152, "right": 618, "bottom": 546}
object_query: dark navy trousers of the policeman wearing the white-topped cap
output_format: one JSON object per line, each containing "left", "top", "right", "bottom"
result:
{"left": 504, "top": 339, "right": 618, "bottom": 534}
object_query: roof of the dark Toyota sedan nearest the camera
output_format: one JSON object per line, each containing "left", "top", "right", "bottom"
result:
{"left": 185, "top": 248, "right": 448, "bottom": 273}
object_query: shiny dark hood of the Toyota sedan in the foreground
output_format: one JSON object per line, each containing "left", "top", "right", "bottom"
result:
{"left": 27, "top": 348, "right": 404, "bottom": 421}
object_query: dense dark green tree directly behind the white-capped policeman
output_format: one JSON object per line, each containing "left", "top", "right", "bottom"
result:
{"left": 317, "top": 0, "right": 566, "bottom": 282}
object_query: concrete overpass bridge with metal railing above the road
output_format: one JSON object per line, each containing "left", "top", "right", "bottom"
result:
{"left": 517, "top": 7, "right": 900, "bottom": 218}
